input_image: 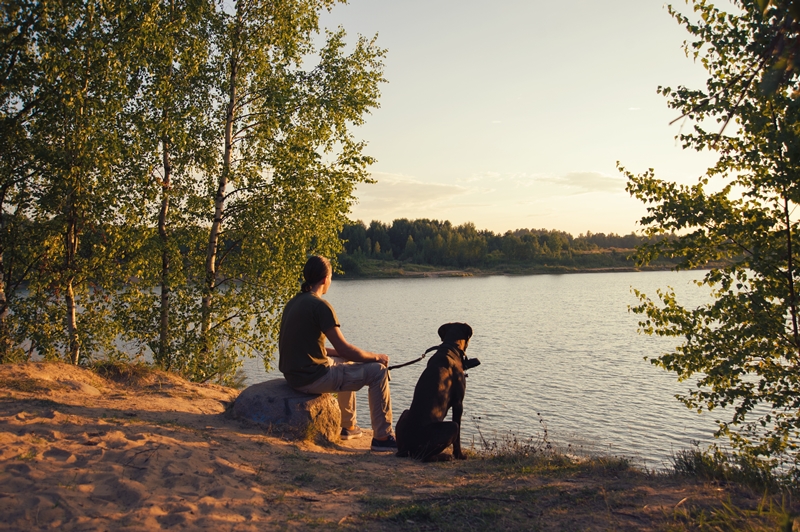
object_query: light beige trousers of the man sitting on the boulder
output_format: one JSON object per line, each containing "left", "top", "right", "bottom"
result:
{"left": 297, "top": 357, "right": 392, "bottom": 438}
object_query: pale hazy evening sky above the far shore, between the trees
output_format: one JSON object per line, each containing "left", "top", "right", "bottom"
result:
{"left": 322, "top": 0, "right": 724, "bottom": 236}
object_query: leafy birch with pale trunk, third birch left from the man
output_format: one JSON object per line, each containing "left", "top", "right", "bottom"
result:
{"left": 14, "top": 1, "right": 145, "bottom": 364}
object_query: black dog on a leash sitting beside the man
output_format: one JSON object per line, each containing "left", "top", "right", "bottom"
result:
{"left": 395, "top": 323, "right": 480, "bottom": 462}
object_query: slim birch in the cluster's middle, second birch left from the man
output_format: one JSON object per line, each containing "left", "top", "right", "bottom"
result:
{"left": 111, "top": 0, "right": 217, "bottom": 370}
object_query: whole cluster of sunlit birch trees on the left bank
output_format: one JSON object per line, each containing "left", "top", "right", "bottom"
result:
{"left": 0, "top": 0, "right": 384, "bottom": 382}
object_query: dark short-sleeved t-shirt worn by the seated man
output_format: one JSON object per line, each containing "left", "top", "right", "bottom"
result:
{"left": 278, "top": 292, "right": 339, "bottom": 388}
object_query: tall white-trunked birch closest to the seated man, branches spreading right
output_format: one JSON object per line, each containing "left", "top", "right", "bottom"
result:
{"left": 182, "top": 0, "right": 383, "bottom": 380}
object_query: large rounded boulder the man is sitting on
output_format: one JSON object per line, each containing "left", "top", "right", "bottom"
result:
{"left": 230, "top": 379, "right": 342, "bottom": 442}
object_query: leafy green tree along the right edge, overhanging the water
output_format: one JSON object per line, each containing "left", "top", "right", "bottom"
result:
{"left": 622, "top": 0, "right": 800, "bottom": 474}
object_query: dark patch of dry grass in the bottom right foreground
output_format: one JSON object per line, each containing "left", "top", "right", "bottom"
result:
{"left": 344, "top": 453, "right": 791, "bottom": 531}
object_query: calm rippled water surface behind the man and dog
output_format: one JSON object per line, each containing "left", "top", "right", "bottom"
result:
{"left": 245, "top": 271, "right": 716, "bottom": 468}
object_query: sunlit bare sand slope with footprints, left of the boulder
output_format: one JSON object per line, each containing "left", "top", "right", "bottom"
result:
{"left": 0, "top": 363, "right": 388, "bottom": 530}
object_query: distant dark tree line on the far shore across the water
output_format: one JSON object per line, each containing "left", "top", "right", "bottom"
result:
{"left": 340, "top": 218, "right": 663, "bottom": 274}
